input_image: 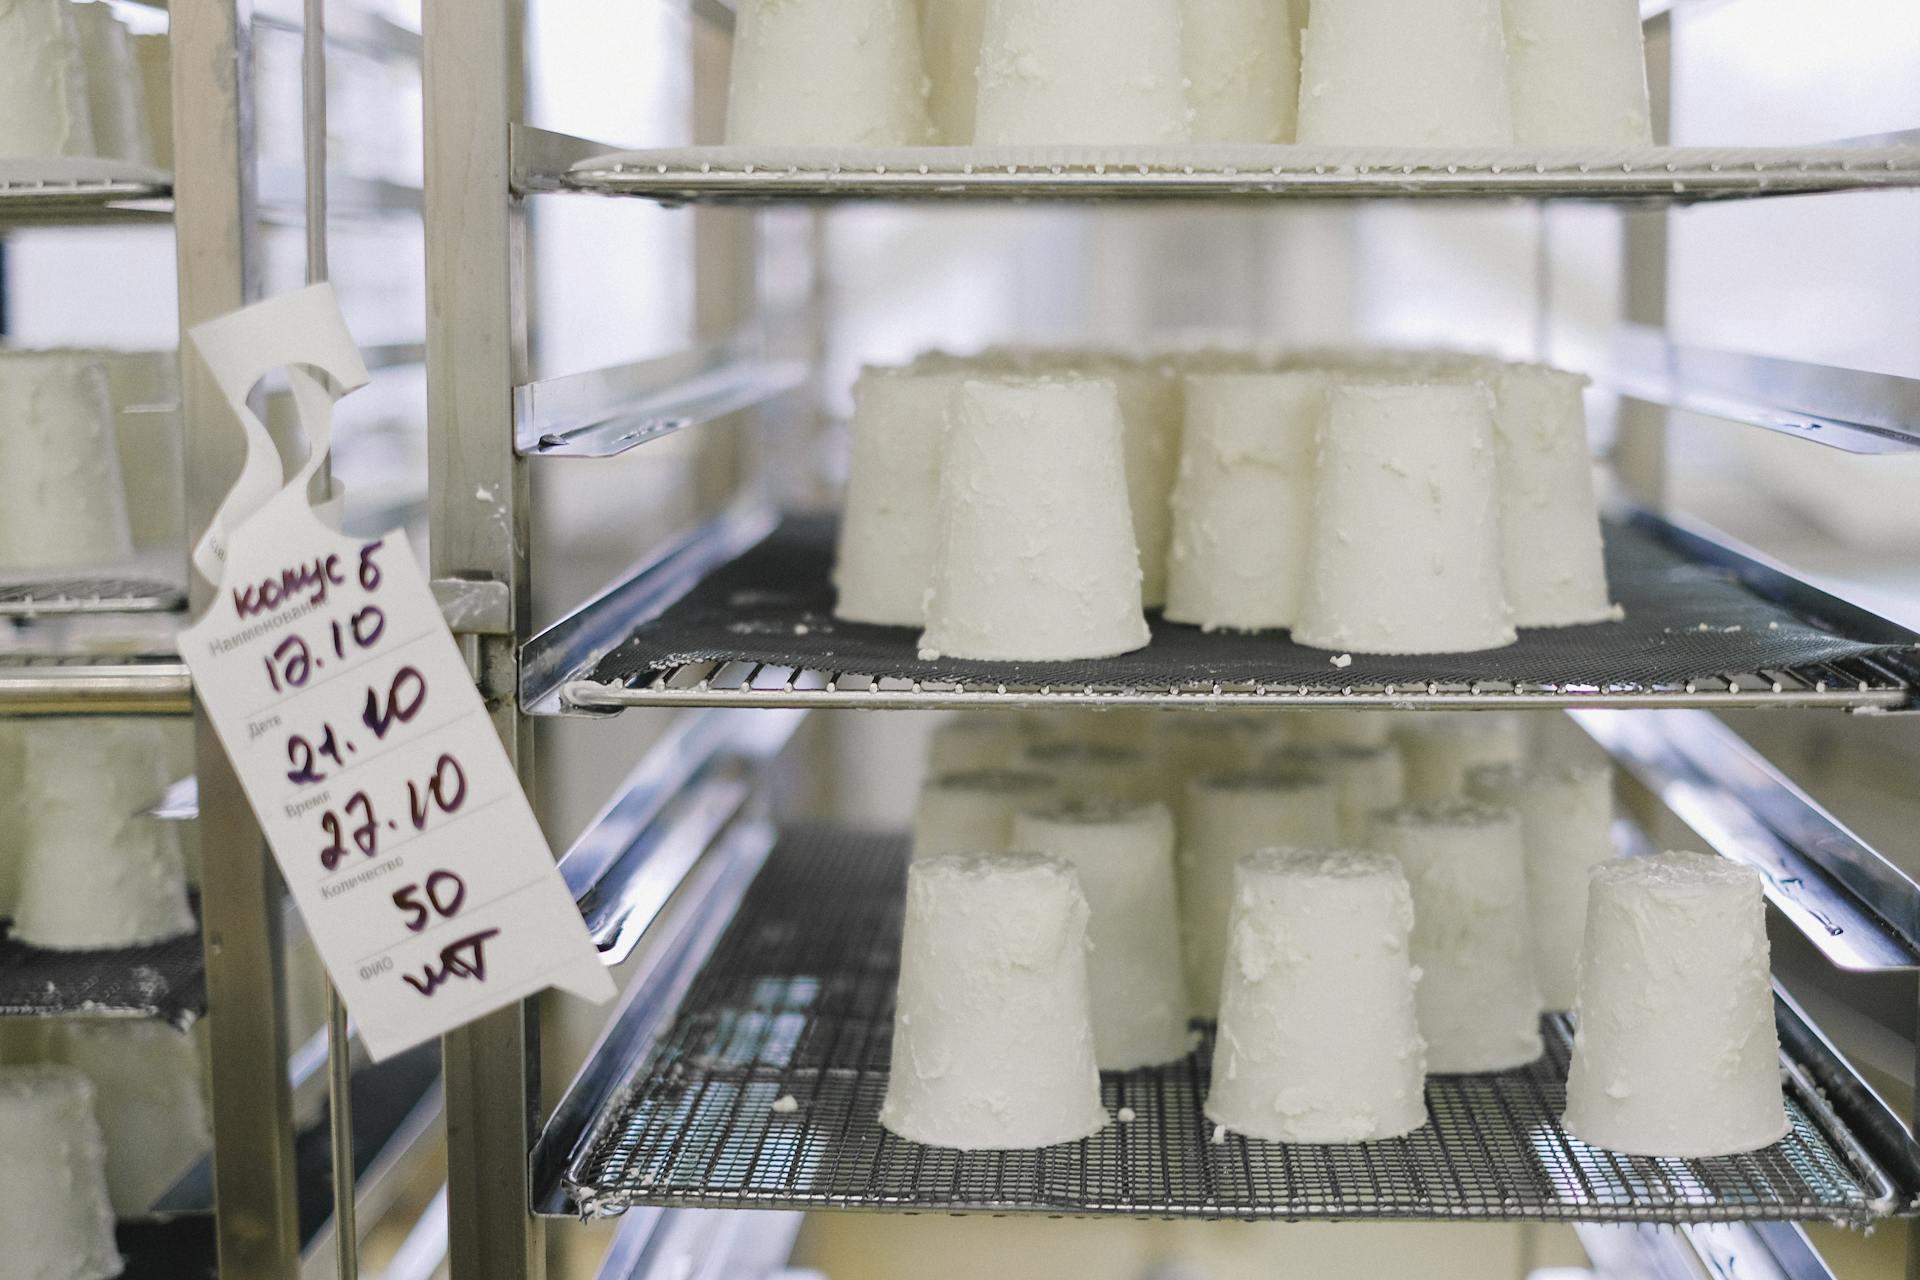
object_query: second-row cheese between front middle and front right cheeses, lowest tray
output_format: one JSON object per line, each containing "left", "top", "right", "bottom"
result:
{"left": 1369, "top": 802, "right": 1542, "bottom": 1073}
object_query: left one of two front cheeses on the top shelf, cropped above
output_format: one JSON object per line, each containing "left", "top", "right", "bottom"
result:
{"left": 973, "top": 0, "right": 1190, "bottom": 146}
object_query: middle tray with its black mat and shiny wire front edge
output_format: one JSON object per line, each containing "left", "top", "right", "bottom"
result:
{"left": 561, "top": 516, "right": 1920, "bottom": 710}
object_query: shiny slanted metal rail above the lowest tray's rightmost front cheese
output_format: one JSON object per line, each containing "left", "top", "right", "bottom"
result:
{"left": 1574, "top": 710, "right": 1920, "bottom": 973}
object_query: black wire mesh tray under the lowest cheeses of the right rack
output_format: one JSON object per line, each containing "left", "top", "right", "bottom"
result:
{"left": 566, "top": 827, "right": 1897, "bottom": 1224}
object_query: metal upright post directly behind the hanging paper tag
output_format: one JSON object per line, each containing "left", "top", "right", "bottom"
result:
{"left": 169, "top": 0, "right": 300, "bottom": 1280}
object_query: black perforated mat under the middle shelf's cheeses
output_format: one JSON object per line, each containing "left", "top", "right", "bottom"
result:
{"left": 586, "top": 516, "right": 1914, "bottom": 706}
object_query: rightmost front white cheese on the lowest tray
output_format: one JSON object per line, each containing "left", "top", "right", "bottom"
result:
{"left": 1565, "top": 854, "right": 1788, "bottom": 1159}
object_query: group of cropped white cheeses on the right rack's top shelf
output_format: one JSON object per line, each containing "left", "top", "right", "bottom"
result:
{"left": 728, "top": 0, "right": 1653, "bottom": 148}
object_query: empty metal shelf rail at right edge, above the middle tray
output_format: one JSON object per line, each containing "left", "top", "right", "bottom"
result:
{"left": 1603, "top": 324, "right": 1920, "bottom": 455}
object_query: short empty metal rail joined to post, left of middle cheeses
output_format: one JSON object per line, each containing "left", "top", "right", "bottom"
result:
{"left": 513, "top": 334, "right": 806, "bottom": 459}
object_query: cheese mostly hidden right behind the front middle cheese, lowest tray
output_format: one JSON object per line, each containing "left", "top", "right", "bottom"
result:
{"left": 1177, "top": 770, "right": 1340, "bottom": 1017}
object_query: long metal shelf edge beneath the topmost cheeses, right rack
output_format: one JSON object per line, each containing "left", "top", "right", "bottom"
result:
{"left": 513, "top": 127, "right": 1920, "bottom": 205}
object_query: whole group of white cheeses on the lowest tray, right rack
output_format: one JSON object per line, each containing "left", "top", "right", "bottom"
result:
{"left": 881, "top": 712, "right": 1786, "bottom": 1155}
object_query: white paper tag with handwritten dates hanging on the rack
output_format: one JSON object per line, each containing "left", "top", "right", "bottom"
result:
{"left": 180, "top": 286, "right": 614, "bottom": 1059}
